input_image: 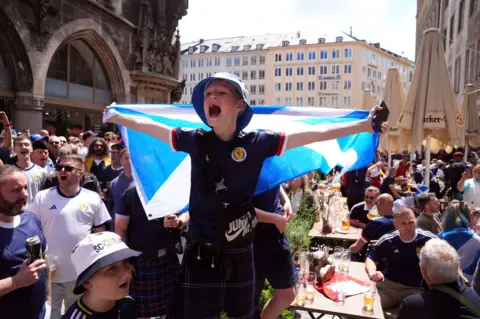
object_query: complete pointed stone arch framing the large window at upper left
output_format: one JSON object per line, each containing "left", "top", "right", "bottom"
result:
{"left": 34, "top": 19, "right": 131, "bottom": 103}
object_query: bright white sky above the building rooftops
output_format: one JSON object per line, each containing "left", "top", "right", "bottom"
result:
{"left": 179, "top": 0, "right": 417, "bottom": 61}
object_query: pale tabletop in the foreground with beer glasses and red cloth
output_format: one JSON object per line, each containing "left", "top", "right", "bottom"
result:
{"left": 290, "top": 262, "right": 385, "bottom": 319}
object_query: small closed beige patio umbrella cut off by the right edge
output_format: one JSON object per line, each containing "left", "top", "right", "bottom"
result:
{"left": 460, "top": 84, "right": 480, "bottom": 156}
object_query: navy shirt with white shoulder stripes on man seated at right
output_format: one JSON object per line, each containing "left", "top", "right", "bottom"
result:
{"left": 368, "top": 228, "right": 437, "bottom": 287}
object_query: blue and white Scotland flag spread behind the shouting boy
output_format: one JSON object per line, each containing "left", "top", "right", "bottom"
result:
{"left": 104, "top": 105, "right": 378, "bottom": 219}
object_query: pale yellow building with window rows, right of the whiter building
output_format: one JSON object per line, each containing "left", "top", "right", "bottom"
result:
{"left": 267, "top": 33, "right": 413, "bottom": 108}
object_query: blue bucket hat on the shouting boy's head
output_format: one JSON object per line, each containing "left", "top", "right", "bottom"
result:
{"left": 192, "top": 72, "right": 254, "bottom": 130}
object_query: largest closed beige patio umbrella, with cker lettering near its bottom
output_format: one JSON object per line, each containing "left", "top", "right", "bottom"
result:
{"left": 398, "top": 29, "right": 462, "bottom": 186}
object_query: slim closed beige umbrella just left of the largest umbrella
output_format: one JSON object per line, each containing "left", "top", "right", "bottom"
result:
{"left": 382, "top": 68, "right": 405, "bottom": 168}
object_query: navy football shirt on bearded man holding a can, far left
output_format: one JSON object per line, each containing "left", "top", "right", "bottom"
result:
{"left": 0, "top": 212, "right": 47, "bottom": 319}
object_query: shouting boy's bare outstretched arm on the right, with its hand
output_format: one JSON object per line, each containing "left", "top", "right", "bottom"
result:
{"left": 286, "top": 106, "right": 388, "bottom": 149}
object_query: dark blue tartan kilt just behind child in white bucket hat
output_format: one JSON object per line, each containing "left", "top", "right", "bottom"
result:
{"left": 129, "top": 251, "right": 180, "bottom": 317}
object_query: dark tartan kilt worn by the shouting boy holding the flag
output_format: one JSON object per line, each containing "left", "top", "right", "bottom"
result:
{"left": 167, "top": 245, "right": 255, "bottom": 319}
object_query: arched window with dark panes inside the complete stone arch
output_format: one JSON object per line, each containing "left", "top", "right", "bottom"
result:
{"left": 45, "top": 40, "right": 112, "bottom": 104}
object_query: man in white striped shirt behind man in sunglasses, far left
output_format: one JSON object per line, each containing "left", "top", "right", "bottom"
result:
{"left": 13, "top": 135, "right": 48, "bottom": 203}
